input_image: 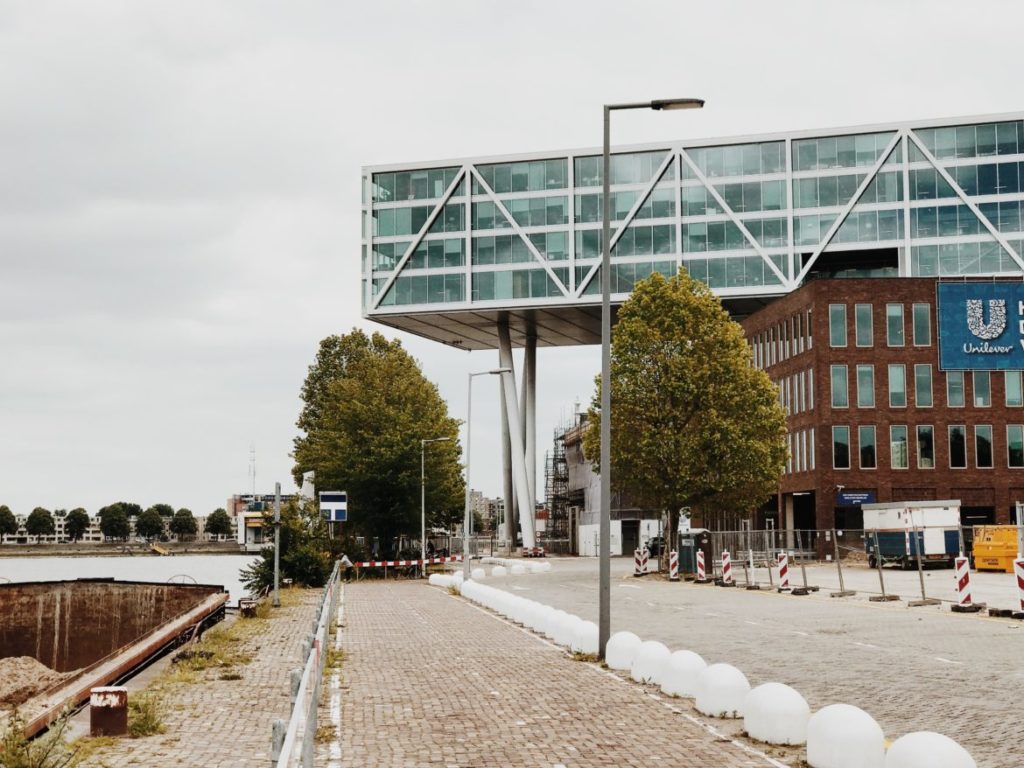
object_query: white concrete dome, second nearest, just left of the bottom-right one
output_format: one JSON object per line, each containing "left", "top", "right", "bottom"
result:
{"left": 807, "top": 705, "right": 886, "bottom": 768}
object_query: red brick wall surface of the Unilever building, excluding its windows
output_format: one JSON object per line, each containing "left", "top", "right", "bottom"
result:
{"left": 742, "top": 278, "right": 1024, "bottom": 528}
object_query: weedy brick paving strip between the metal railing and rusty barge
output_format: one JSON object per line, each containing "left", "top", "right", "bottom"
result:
{"left": 76, "top": 590, "right": 321, "bottom": 768}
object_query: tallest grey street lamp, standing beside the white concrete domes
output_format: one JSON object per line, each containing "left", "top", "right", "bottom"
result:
{"left": 597, "top": 98, "right": 703, "bottom": 658}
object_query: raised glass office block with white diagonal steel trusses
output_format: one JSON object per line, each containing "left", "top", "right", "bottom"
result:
{"left": 362, "top": 115, "right": 1024, "bottom": 348}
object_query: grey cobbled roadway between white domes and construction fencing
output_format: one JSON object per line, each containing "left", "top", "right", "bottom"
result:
{"left": 499, "top": 558, "right": 1024, "bottom": 768}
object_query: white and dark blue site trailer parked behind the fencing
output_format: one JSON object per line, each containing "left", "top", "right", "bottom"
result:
{"left": 861, "top": 500, "right": 961, "bottom": 568}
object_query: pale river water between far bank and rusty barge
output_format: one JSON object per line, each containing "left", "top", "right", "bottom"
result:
{"left": 0, "top": 555, "right": 259, "bottom": 605}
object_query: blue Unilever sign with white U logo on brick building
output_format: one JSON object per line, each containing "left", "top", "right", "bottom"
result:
{"left": 938, "top": 283, "right": 1024, "bottom": 371}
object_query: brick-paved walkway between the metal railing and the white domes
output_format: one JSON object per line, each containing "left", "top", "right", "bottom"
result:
{"left": 327, "top": 582, "right": 780, "bottom": 768}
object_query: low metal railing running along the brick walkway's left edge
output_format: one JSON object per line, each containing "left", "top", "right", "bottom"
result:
{"left": 270, "top": 563, "right": 341, "bottom": 768}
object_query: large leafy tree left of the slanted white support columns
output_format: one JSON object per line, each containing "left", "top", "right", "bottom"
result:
{"left": 293, "top": 330, "right": 463, "bottom": 553}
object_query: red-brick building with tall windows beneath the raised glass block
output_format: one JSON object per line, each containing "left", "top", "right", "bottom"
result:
{"left": 742, "top": 278, "right": 1024, "bottom": 529}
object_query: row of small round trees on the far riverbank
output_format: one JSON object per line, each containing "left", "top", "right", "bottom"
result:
{"left": 0, "top": 502, "right": 231, "bottom": 542}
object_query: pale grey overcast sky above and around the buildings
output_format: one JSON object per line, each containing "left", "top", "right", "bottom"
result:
{"left": 0, "top": 0, "right": 1024, "bottom": 514}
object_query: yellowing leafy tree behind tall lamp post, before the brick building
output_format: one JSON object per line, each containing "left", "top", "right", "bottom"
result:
{"left": 584, "top": 269, "right": 786, "bottom": 531}
